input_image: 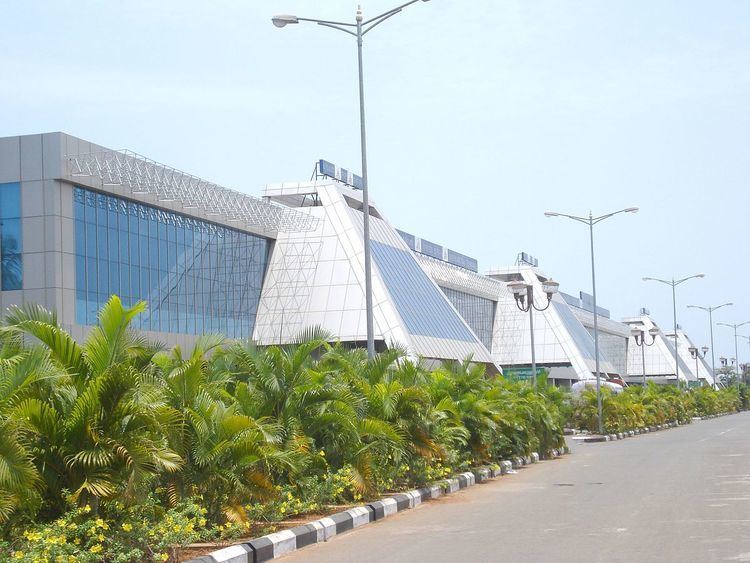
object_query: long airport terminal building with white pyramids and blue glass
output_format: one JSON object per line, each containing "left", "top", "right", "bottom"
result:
{"left": 0, "top": 133, "right": 716, "bottom": 385}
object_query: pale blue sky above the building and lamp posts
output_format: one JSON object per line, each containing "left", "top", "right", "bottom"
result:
{"left": 0, "top": 0, "right": 750, "bottom": 362}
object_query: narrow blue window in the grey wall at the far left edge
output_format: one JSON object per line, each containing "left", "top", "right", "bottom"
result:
{"left": 0, "top": 182, "right": 23, "bottom": 291}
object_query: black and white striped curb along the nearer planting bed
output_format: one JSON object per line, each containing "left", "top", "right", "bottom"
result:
{"left": 187, "top": 446, "right": 570, "bottom": 563}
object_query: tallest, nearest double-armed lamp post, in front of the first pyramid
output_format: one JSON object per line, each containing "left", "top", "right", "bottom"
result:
{"left": 271, "top": 0, "right": 429, "bottom": 358}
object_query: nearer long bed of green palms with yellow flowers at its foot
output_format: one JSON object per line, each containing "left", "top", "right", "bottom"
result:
{"left": 0, "top": 296, "right": 570, "bottom": 561}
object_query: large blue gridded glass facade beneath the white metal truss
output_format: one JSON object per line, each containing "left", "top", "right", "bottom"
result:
{"left": 73, "top": 187, "right": 270, "bottom": 338}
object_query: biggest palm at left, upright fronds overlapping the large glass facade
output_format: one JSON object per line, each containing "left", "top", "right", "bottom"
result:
{"left": 3, "top": 296, "right": 181, "bottom": 513}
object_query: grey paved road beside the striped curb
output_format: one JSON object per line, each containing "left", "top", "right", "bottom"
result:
{"left": 283, "top": 413, "right": 750, "bottom": 563}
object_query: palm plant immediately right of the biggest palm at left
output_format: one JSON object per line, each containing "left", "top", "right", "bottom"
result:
{"left": 153, "top": 335, "right": 294, "bottom": 522}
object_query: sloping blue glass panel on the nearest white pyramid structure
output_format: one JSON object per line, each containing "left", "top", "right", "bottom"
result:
{"left": 371, "top": 241, "right": 476, "bottom": 342}
